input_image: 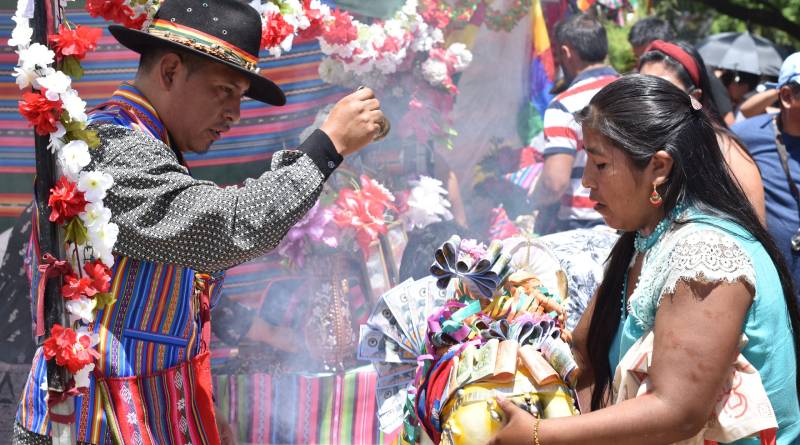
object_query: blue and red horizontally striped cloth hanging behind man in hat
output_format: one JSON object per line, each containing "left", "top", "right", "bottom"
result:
{"left": 0, "top": 8, "right": 343, "bottom": 231}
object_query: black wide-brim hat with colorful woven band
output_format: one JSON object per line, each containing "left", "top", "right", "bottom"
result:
{"left": 108, "top": 0, "right": 286, "bottom": 105}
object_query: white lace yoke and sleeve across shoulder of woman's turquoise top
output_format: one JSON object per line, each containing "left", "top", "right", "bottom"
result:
{"left": 628, "top": 224, "right": 756, "bottom": 330}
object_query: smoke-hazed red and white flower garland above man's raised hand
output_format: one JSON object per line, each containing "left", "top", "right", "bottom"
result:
{"left": 318, "top": 0, "right": 472, "bottom": 147}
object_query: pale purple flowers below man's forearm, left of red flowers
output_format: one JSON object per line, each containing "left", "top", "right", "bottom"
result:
{"left": 278, "top": 201, "right": 339, "bottom": 267}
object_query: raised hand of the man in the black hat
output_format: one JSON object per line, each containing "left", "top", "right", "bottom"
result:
{"left": 320, "top": 88, "right": 386, "bottom": 156}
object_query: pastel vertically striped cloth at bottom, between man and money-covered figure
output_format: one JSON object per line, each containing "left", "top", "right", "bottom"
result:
{"left": 214, "top": 367, "right": 397, "bottom": 445}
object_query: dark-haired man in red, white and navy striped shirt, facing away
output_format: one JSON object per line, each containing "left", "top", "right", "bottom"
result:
{"left": 531, "top": 14, "right": 619, "bottom": 231}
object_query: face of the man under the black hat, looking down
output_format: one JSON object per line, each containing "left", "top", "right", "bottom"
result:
{"left": 162, "top": 62, "right": 250, "bottom": 154}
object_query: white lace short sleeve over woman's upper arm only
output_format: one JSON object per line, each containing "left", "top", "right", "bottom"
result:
{"left": 659, "top": 229, "right": 756, "bottom": 303}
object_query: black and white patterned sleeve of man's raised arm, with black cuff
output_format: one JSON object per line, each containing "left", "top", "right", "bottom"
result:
{"left": 88, "top": 126, "right": 342, "bottom": 272}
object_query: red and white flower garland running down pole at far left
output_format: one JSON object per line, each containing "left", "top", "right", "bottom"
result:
{"left": 8, "top": 6, "right": 115, "bottom": 388}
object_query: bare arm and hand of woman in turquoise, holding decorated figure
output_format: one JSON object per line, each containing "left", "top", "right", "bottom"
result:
{"left": 492, "top": 282, "right": 753, "bottom": 445}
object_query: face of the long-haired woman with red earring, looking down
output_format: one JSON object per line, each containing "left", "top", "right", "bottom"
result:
{"left": 582, "top": 125, "right": 663, "bottom": 232}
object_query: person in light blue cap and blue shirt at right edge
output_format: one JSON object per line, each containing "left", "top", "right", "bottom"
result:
{"left": 732, "top": 52, "right": 800, "bottom": 306}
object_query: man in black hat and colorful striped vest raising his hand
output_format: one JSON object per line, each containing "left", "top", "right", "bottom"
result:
{"left": 13, "top": 0, "right": 388, "bottom": 445}
